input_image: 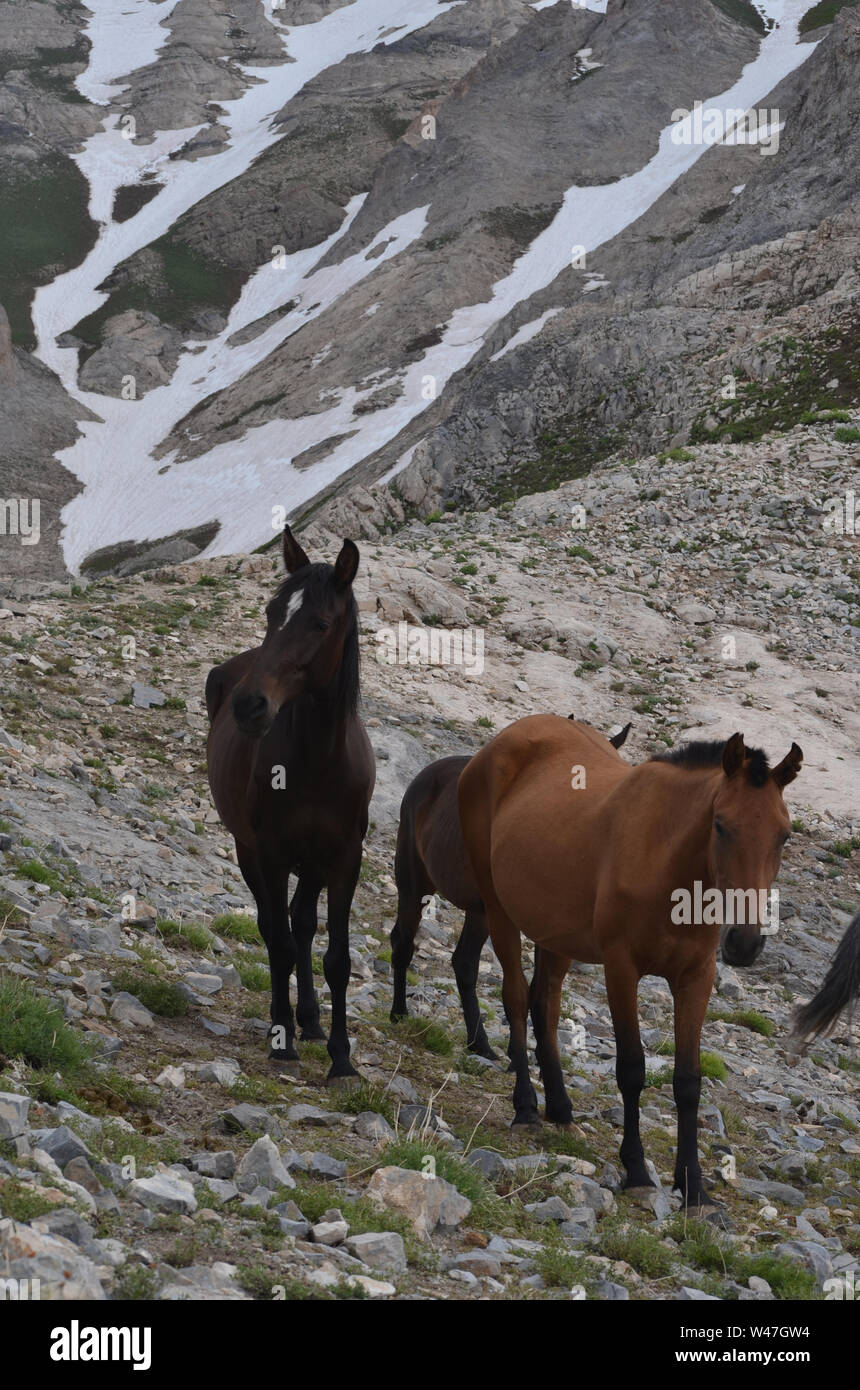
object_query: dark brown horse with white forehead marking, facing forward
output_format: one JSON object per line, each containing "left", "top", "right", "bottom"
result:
{"left": 206, "top": 527, "right": 375, "bottom": 1081}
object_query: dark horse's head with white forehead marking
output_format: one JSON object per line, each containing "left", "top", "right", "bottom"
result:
{"left": 233, "top": 527, "right": 358, "bottom": 738}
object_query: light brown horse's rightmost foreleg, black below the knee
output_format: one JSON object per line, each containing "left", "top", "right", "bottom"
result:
{"left": 670, "top": 952, "right": 716, "bottom": 1207}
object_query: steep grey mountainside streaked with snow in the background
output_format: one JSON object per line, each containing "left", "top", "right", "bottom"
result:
{"left": 0, "top": 0, "right": 860, "bottom": 577}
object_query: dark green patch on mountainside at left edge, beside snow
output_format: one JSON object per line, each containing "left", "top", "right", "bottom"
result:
{"left": 0, "top": 152, "right": 99, "bottom": 344}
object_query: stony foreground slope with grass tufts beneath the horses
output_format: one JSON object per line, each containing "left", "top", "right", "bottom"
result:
{"left": 0, "top": 425, "right": 860, "bottom": 1301}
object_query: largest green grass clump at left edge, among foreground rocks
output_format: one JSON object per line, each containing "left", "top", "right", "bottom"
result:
{"left": 0, "top": 977, "right": 94, "bottom": 1084}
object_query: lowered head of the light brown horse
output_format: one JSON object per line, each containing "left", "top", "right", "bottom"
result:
{"left": 709, "top": 734, "right": 803, "bottom": 966}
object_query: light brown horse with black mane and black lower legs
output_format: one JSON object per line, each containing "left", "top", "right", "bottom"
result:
{"left": 458, "top": 714, "right": 803, "bottom": 1205}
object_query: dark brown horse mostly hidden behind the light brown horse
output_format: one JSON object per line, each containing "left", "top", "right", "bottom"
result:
{"left": 390, "top": 714, "right": 631, "bottom": 1059}
